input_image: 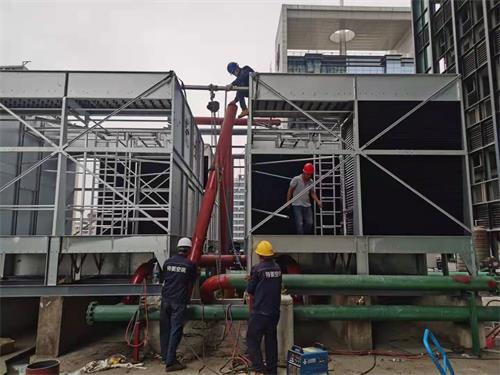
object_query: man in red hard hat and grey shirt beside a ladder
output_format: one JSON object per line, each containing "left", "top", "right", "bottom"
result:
{"left": 286, "top": 163, "right": 321, "bottom": 234}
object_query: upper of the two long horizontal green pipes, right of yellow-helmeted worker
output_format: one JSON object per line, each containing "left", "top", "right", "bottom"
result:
{"left": 219, "top": 274, "right": 497, "bottom": 291}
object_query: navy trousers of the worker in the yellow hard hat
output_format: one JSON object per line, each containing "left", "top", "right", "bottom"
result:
{"left": 247, "top": 314, "right": 279, "bottom": 374}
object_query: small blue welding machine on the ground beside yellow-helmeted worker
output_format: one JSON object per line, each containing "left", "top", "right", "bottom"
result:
{"left": 286, "top": 345, "right": 328, "bottom": 375}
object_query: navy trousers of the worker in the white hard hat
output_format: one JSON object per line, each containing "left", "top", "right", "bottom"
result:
{"left": 160, "top": 299, "right": 187, "bottom": 366}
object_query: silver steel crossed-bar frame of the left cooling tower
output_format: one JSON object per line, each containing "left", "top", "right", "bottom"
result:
{"left": 0, "top": 72, "right": 203, "bottom": 285}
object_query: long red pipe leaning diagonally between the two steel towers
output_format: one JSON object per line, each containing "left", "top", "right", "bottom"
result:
{"left": 188, "top": 104, "right": 237, "bottom": 264}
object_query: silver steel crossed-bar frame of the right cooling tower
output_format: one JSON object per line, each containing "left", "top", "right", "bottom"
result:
{"left": 246, "top": 75, "right": 477, "bottom": 274}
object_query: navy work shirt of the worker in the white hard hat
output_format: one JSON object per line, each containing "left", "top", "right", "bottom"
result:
{"left": 161, "top": 255, "right": 197, "bottom": 304}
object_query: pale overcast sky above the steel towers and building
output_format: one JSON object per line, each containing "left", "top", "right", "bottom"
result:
{"left": 0, "top": 0, "right": 410, "bottom": 116}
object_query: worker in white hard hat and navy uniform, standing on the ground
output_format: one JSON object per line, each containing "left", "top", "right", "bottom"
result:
{"left": 160, "top": 237, "right": 197, "bottom": 372}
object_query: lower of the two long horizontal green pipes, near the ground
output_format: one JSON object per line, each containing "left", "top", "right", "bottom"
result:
{"left": 87, "top": 302, "right": 500, "bottom": 324}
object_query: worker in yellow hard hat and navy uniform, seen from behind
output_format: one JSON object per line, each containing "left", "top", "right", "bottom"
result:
{"left": 247, "top": 241, "right": 281, "bottom": 374}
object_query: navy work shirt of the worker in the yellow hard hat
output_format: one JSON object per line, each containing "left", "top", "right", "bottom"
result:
{"left": 247, "top": 259, "right": 281, "bottom": 316}
